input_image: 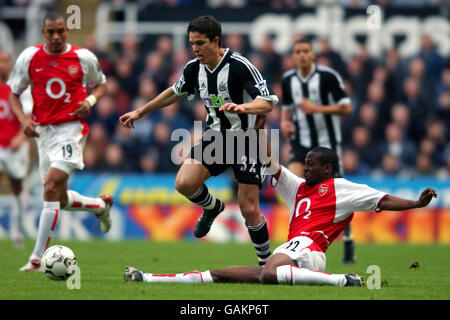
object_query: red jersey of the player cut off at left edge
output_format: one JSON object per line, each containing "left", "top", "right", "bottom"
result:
{"left": 0, "top": 83, "right": 20, "bottom": 148}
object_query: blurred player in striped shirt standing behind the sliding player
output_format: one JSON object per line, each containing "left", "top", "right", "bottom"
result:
{"left": 280, "top": 39, "right": 355, "bottom": 264}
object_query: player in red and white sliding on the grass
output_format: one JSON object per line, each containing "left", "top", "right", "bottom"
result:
{"left": 124, "top": 147, "right": 437, "bottom": 286}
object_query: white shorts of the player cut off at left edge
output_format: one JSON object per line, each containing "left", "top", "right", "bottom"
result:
{"left": 0, "top": 140, "right": 30, "bottom": 180}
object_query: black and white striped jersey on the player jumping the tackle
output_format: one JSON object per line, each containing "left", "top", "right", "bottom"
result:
{"left": 172, "top": 48, "right": 278, "bottom": 132}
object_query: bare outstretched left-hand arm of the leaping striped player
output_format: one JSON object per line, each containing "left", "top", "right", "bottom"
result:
{"left": 119, "top": 87, "right": 183, "bottom": 128}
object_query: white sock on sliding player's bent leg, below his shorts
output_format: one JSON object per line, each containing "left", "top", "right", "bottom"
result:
{"left": 277, "top": 265, "right": 347, "bottom": 287}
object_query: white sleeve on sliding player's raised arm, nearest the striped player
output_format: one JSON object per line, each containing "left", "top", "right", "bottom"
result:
{"left": 270, "top": 166, "right": 305, "bottom": 212}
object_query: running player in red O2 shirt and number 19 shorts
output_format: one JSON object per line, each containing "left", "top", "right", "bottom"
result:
{"left": 8, "top": 12, "right": 113, "bottom": 271}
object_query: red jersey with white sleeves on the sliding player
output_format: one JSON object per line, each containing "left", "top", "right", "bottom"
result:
{"left": 271, "top": 166, "right": 386, "bottom": 252}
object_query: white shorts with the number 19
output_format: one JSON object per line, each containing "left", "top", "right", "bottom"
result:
{"left": 35, "top": 121, "right": 87, "bottom": 181}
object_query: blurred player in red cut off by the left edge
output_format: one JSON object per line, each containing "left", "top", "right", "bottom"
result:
{"left": 0, "top": 50, "right": 30, "bottom": 247}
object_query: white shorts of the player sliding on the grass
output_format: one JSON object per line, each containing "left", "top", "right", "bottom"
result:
{"left": 273, "top": 236, "right": 327, "bottom": 272}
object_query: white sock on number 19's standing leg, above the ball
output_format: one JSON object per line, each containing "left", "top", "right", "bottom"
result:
{"left": 30, "top": 201, "right": 60, "bottom": 260}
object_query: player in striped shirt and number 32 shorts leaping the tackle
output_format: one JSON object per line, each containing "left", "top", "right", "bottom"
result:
{"left": 120, "top": 16, "right": 278, "bottom": 265}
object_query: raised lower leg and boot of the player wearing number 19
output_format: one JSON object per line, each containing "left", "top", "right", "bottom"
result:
{"left": 64, "top": 190, "right": 114, "bottom": 233}
